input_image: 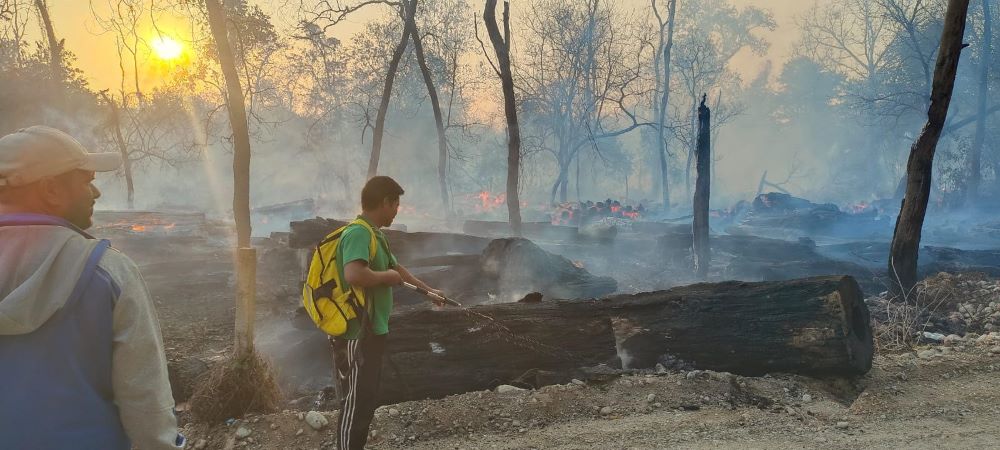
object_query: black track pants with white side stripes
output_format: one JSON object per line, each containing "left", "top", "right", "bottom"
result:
{"left": 333, "top": 333, "right": 387, "bottom": 450}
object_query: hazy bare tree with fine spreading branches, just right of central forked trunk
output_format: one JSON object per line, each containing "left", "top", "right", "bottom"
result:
{"left": 516, "top": 0, "right": 653, "bottom": 202}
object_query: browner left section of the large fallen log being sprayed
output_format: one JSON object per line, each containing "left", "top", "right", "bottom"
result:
{"left": 380, "top": 301, "right": 618, "bottom": 404}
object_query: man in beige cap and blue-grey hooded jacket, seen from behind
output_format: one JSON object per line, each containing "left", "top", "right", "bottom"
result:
{"left": 0, "top": 126, "right": 184, "bottom": 450}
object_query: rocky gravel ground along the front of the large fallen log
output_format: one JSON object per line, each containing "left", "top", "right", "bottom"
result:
{"left": 178, "top": 333, "right": 1000, "bottom": 449}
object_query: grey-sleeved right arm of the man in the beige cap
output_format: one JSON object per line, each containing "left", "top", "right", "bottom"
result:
{"left": 110, "top": 258, "right": 179, "bottom": 450}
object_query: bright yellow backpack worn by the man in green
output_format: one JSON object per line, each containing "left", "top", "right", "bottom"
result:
{"left": 302, "top": 219, "right": 378, "bottom": 336}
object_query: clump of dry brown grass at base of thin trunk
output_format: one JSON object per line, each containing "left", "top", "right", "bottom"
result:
{"left": 189, "top": 352, "right": 281, "bottom": 423}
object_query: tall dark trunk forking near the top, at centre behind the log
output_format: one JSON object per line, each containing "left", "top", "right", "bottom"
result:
{"left": 483, "top": 0, "right": 521, "bottom": 236}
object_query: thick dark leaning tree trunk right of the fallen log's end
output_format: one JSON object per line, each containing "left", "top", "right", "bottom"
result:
{"left": 889, "top": 0, "right": 969, "bottom": 299}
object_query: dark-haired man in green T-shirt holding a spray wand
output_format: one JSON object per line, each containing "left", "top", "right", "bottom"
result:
{"left": 332, "top": 176, "right": 441, "bottom": 450}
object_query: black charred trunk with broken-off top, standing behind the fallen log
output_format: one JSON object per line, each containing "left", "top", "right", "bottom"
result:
{"left": 691, "top": 95, "right": 712, "bottom": 279}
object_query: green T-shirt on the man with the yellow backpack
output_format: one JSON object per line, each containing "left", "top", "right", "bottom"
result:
{"left": 337, "top": 216, "right": 396, "bottom": 339}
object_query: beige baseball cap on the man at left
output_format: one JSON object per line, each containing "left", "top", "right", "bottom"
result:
{"left": 0, "top": 125, "right": 122, "bottom": 187}
